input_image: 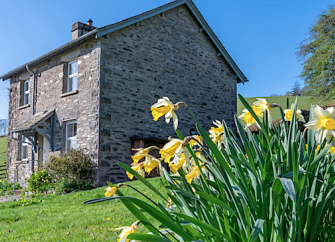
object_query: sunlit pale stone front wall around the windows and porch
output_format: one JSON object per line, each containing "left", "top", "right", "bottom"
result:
{"left": 7, "top": 40, "right": 101, "bottom": 185}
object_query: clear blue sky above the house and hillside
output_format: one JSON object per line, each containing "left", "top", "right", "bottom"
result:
{"left": 0, "top": 0, "right": 333, "bottom": 119}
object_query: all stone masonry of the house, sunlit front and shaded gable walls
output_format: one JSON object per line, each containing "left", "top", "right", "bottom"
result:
{"left": 3, "top": 2, "right": 243, "bottom": 186}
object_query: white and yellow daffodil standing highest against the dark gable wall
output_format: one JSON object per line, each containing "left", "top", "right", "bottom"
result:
{"left": 151, "top": 97, "right": 185, "bottom": 129}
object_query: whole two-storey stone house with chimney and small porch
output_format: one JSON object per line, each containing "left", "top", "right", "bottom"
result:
{"left": 0, "top": 0, "right": 248, "bottom": 185}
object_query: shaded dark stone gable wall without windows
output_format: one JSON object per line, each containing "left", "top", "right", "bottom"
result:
{"left": 98, "top": 6, "right": 236, "bottom": 185}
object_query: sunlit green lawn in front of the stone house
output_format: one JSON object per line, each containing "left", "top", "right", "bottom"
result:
{"left": 0, "top": 178, "right": 162, "bottom": 241}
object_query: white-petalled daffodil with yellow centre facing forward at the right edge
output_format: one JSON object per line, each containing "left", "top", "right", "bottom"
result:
{"left": 305, "top": 105, "right": 335, "bottom": 144}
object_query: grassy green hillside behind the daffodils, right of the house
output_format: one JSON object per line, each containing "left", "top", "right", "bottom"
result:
{"left": 237, "top": 96, "right": 317, "bottom": 120}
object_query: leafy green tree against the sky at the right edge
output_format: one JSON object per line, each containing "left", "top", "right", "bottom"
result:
{"left": 297, "top": 5, "right": 335, "bottom": 102}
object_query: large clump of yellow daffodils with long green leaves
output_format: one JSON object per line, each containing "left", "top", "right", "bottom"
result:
{"left": 85, "top": 96, "right": 335, "bottom": 242}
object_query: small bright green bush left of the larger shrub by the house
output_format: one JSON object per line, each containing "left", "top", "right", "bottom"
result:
{"left": 27, "top": 170, "right": 54, "bottom": 193}
